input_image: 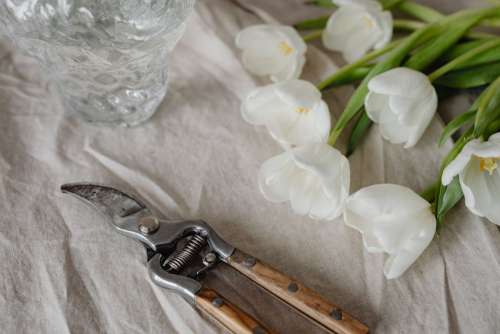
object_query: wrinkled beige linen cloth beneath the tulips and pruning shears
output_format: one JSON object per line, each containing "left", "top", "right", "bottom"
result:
{"left": 0, "top": 0, "right": 500, "bottom": 334}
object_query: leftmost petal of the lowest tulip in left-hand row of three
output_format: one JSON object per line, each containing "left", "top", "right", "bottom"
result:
{"left": 259, "top": 152, "right": 296, "bottom": 203}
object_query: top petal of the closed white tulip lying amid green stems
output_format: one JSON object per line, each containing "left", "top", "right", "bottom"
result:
{"left": 368, "top": 67, "right": 431, "bottom": 98}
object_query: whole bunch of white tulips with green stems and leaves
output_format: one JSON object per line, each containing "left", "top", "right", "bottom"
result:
{"left": 236, "top": 0, "right": 500, "bottom": 279}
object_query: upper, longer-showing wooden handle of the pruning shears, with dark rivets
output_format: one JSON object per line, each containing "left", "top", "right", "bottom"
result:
{"left": 227, "top": 250, "right": 368, "bottom": 334}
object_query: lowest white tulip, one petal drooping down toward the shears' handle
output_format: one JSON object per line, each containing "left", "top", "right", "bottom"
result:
{"left": 344, "top": 184, "right": 436, "bottom": 279}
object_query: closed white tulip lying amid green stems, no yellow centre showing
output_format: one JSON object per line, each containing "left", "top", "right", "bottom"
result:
{"left": 365, "top": 67, "right": 438, "bottom": 148}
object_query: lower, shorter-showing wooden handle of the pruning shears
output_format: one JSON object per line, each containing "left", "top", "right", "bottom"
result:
{"left": 196, "top": 289, "right": 273, "bottom": 334}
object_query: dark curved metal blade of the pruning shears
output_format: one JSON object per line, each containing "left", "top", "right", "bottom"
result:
{"left": 61, "top": 183, "right": 150, "bottom": 228}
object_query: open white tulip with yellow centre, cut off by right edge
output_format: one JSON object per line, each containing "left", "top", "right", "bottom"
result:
{"left": 442, "top": 133, "right": 500, "bottom": 225}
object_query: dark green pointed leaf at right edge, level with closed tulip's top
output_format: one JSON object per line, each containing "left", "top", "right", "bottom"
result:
{"left": 434, "top": 62, "right": 500, "bottom": 89}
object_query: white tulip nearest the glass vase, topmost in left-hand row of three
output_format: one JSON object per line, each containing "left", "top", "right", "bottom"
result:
{"left": 236, "top": 24, "right": 307, "bottom": 82}
